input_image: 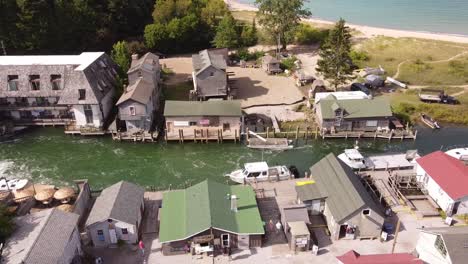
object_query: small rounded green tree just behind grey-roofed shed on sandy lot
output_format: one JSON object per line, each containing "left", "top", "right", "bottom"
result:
{"left": 213, "top": 14, "right": 239, "bottom": 48}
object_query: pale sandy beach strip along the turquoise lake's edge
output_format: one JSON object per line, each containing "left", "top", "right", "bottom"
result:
{"left": 228, "top": 0, "right": 468, "bottom": 44}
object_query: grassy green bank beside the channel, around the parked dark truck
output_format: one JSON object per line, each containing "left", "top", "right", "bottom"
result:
{"left": 388, "top": 87, "right": 468, "bottom": 125}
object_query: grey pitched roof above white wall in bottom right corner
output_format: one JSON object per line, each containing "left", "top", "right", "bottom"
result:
{"left": 421, "top": 226, "right": 468, "bottom": 263}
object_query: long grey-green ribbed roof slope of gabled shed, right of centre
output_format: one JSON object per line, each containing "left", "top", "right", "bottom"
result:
{"left": 310, "top": 153, "right": 382, "bottom": 223}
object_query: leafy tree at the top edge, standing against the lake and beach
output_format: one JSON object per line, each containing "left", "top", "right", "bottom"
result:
{"left": 255, "top": 0, "right": 311, "bottom": 49}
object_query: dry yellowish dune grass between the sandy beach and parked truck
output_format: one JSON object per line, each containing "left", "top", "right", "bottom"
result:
{"left": 356, "top": 36, "right": 468, "bottom": 80}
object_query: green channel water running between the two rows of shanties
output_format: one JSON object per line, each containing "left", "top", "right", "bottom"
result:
{"left": 0, "top": 127, "right": 468, "bottom": 189}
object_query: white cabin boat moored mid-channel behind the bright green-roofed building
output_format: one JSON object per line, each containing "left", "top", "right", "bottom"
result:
{"left": 226, "top": 161, "right": 294, "bottom": 183}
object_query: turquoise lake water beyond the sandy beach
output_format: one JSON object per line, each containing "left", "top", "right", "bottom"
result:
{"left": 240, "top": 0, "right": 468, "bottom": 35}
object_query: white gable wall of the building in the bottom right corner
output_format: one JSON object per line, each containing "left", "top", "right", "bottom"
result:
{"left": 416, "top": 232, "right": 452, "bottom": 264}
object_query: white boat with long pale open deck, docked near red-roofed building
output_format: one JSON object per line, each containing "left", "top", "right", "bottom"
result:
{"left": 338, "top": 148, "right": 420, "bottom": 170}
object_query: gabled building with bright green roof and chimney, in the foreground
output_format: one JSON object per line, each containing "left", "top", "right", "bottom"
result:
{"left": 159, "top": 180, "right": 265, "bottom": 255}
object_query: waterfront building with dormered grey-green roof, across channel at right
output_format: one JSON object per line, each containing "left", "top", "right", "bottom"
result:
{"left": 315, "top": 94, "right": 393, "bottom": 134}
